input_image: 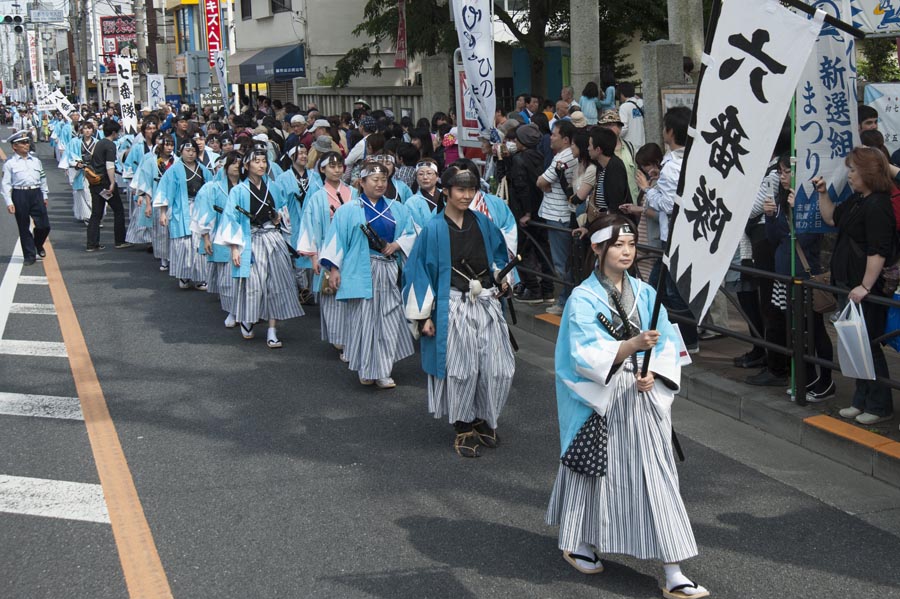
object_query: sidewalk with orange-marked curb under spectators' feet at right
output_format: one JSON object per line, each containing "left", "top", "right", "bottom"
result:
{"left": 516, "top": 303, "right": 900, "bottom": 488}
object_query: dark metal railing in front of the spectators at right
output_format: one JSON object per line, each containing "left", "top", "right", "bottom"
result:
{"left": 518, "top": 221, "right": 900, "bottom": 406}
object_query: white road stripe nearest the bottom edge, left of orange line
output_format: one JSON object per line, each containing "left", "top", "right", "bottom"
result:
{"left": 0, "top": 474, "right": 109, "bottom": 524}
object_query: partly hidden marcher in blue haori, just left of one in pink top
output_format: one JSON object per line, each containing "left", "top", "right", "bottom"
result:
{"left": 275, "top": 144, "right": 318, "bottom": 301}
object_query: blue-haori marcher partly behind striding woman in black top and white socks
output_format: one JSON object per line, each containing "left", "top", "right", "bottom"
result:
{"left": 191, "top": 152, "right": 241, "bottom": 329}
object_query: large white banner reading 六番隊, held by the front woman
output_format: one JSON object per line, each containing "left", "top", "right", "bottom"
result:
{"left": 666, "top": 0, "right": 825, "bottom": 322}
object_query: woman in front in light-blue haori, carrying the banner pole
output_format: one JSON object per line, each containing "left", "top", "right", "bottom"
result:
{"left": 547, "top": 215, "right": 709, "bottom": 599}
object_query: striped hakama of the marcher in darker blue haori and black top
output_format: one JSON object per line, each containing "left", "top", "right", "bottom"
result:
{"left": 428, "top": 289, "right": 516, "bottom": 428}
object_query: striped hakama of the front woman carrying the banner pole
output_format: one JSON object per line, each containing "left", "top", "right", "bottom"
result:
{"left": 546, "top": 362, "right": 697, "bottom": 563}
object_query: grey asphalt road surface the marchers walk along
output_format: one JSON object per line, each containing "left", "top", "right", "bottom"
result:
{"left": 0, "top": 146, "right": 900, "bottom": 599}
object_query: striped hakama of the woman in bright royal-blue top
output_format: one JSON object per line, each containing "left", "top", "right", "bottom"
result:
{"left": 344, "top": 255, "right": 415, "bottom": 380}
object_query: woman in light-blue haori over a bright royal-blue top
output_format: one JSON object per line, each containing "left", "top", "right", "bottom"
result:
{"left": 319, "top": 160, "right": 415, "bottom": 389}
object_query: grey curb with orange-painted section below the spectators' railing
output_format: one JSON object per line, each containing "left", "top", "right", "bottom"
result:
{"left": 517, "top": 314, "right": 900, "bottom": 488}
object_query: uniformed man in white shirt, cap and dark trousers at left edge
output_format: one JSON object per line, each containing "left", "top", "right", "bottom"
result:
{"left": 0, "top": 130, "right": 50, "bottom": 265}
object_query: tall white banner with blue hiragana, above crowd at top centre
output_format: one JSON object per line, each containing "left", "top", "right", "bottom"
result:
{"left": 453, "top": 0, "right": 497, "bottom": 141}
